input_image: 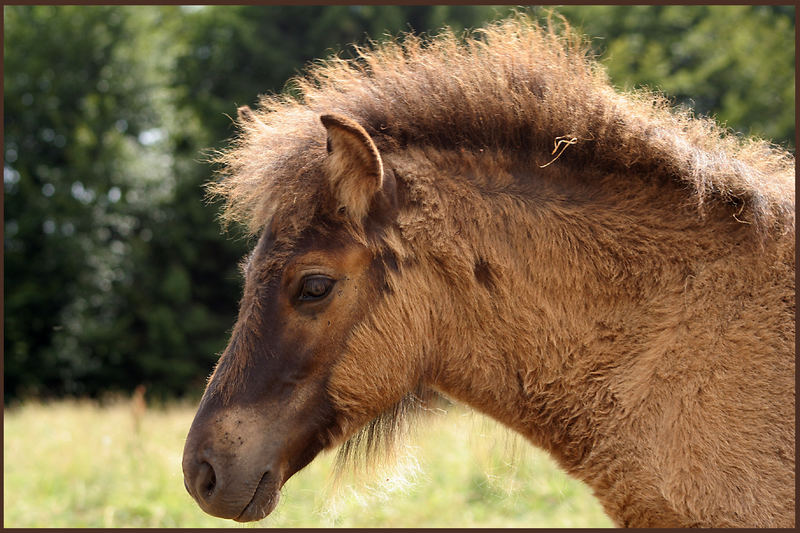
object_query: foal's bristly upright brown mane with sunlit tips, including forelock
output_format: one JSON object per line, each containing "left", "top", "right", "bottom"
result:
{"left": 209, "top": 15, "right": 794, "bottom": 233}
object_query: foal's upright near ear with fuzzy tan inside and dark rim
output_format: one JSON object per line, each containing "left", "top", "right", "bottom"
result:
{"left": 320, "top": 114, "right": 384, "bottom": 222}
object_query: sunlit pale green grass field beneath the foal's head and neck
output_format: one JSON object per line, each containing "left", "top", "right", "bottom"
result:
{"left": 3, "top": 396, "right": 612, "bottom": 528}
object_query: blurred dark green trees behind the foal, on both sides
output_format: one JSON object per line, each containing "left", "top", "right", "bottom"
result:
{"left": 3, "top": 6, "right": 795, "bottom": 402}
